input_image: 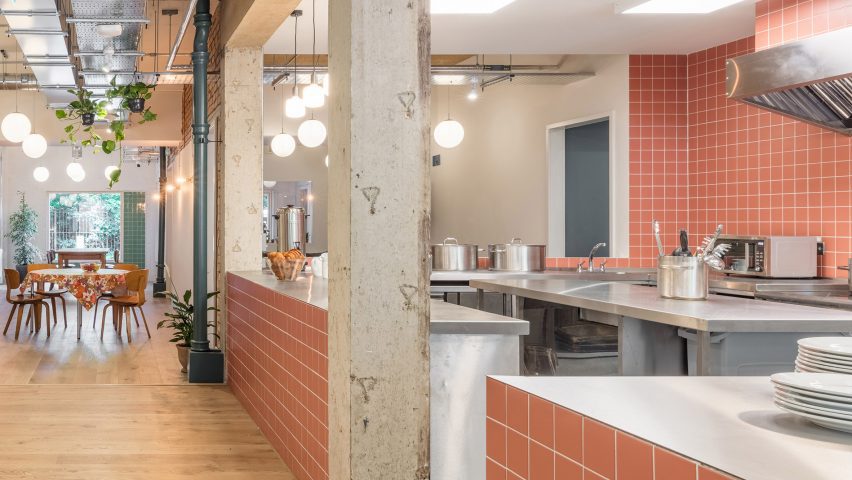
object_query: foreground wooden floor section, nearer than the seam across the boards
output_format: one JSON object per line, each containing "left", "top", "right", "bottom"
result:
{"left": 0, "top": 385, "right": 295, "bottom": 480}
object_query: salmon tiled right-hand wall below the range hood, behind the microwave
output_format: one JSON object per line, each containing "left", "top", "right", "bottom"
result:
{"left": 687, "top": 36, "right": 852, "bottom": 276}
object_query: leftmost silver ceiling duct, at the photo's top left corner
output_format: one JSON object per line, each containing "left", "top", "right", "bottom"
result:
{"left": 0, "top": 0, "right": 76, "bottom": 104}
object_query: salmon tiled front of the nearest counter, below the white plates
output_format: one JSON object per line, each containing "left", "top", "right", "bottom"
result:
{"left": 485, "top": 378, "right": 735, "bottom": 480}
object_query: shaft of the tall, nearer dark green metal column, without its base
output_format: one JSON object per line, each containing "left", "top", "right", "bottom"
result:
{"left": 191, "top": 0, "right": 211, "bottom": 352}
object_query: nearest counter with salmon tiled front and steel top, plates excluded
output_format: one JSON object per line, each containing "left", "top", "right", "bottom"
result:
{"left": 486, "top": 377, "right": 852, "bottom": 480}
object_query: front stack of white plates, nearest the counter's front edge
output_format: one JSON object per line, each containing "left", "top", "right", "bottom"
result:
{"left": 771, "top": 373, "right": 852, "bottom": 433}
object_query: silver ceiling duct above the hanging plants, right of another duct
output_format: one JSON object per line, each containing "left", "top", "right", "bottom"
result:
{"left": 67, "top": 0, "right": 152, "bottom": 95}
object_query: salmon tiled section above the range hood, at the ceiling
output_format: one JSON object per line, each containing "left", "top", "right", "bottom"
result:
{"left": 754, "top": 0, "right": 852, "bottom": 50}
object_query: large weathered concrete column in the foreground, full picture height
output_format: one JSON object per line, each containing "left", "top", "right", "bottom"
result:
{"left": 329, "top": 0, "right": 430, "bottom": 480}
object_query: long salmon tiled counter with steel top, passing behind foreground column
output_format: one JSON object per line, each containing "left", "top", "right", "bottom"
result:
{"left": 226, "top": 271, "right": 529, "bottom": 480}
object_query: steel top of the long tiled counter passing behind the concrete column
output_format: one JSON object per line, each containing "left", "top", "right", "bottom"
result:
{"left": 229, "top": 271, "right": 530, "bottom": 335}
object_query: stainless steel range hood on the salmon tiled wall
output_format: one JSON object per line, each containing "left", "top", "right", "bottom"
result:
{"left": 727, "top": 27, "right": 852, "bottom": 136}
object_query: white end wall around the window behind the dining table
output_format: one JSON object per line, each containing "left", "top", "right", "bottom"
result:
{"left": 0, "top": 146, "right": 159, "bottom": 272}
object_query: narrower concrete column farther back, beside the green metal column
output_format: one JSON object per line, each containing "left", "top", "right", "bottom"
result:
{"left": 216, "top": 46, "right": 263, "bottom": 352}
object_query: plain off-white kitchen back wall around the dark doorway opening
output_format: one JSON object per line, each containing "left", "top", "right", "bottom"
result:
{"left": 432, "top": 55, "right": 629, "bottom": 255}
